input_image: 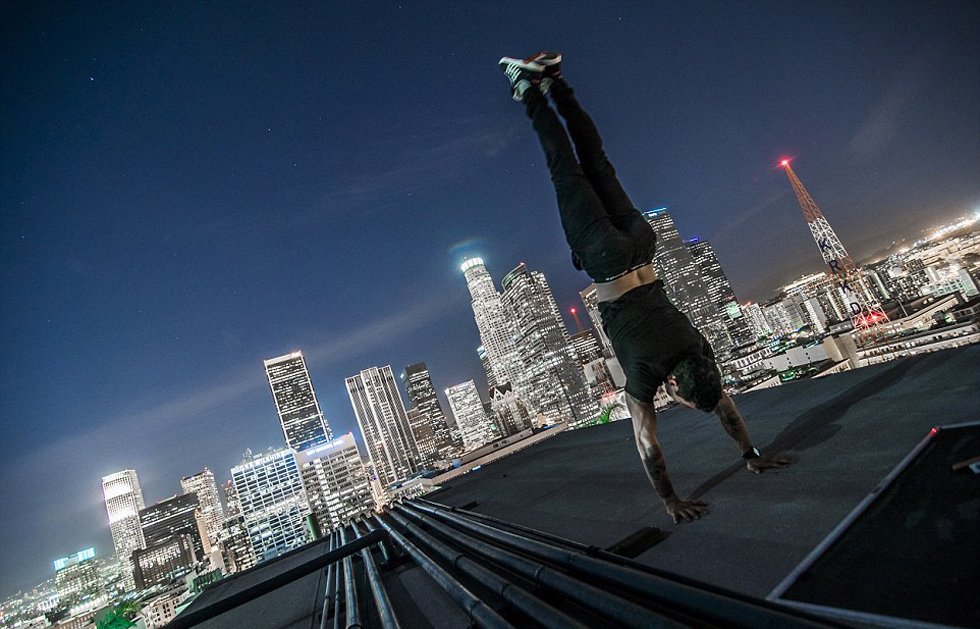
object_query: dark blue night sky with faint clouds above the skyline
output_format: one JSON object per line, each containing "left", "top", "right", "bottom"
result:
{"left": 0, "top": 1, "right": 980, "bottom": 596}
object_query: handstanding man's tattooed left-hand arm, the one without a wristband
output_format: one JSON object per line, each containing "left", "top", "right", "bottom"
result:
{"left": 626, "top": 393, "right": 708, "bottom": 524}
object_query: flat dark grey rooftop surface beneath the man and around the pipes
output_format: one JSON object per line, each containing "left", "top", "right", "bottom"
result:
{"left": 180, "top": 345, "right": 980, "bottom": 629}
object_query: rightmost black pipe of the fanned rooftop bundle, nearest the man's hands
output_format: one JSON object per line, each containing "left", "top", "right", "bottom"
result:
{"left": 411, "top": 503, "right": 839, "bottom": 629}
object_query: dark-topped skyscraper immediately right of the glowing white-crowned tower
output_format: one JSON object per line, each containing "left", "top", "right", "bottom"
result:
{"left": 501, "top": 263, "right": 599, "bottom": 426}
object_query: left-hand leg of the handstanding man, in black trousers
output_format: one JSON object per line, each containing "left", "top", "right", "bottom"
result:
{"left": 523, "top": 88, "right": 633, "bottom": 281}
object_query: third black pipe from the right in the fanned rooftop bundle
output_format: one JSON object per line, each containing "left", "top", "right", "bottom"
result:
{"left": 389, "top": 507, "right": 588, "bottom": 629}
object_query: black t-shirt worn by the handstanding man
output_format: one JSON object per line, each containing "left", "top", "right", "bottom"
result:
{"left": 599, "top": 280, "right": 714, "bottom": 403}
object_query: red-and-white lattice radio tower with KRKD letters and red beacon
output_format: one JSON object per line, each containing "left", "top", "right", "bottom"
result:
{"left": 779, "top": 159, "right": 888, "bottom": 332}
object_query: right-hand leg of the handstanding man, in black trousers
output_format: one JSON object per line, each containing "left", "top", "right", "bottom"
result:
{"left": 551, "top": 77, "right": 653, "bottom": 250}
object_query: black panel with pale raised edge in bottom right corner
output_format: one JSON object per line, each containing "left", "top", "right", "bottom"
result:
{"left": 781, "top": 423, "right": 980, "bottom": 627}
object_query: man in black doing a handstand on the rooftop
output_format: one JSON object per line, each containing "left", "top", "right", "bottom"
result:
{"left": 500, "top": 52, "right": 793, "bottom": 523}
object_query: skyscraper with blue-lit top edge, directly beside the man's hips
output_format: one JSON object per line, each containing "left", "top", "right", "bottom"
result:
{"left": 643, "top": 207, "right": 731, "bottom": 352}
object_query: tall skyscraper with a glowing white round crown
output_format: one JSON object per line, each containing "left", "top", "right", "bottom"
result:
{"left": 460, "top": 258, "right": 525, "bottom": 395}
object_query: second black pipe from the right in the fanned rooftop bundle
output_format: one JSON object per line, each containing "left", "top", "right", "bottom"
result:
{"left": 392, "top": 506, "right": 690, "bottom": 629}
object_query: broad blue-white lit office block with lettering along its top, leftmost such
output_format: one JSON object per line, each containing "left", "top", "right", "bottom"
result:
{"left": 231, "top": 449, "right": 310, "bottom": 562}
